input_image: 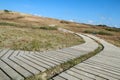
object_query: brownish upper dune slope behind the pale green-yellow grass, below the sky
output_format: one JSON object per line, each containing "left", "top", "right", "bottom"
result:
{"left": 0, "top": 11, "right": 120, "bottom": 47}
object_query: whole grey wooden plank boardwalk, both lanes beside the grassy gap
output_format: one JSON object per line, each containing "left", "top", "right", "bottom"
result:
{"left": 0, "top": 29, "right": 120, "bottom": 80}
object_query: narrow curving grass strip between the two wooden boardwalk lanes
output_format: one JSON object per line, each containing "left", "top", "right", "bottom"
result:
{"left": 25, "top": 36, "right": 104, "bottom": 80}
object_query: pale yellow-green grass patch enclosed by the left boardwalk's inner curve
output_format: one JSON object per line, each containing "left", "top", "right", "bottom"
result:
{"left": 0, "top": 26, "right": 83, "bottom": 51}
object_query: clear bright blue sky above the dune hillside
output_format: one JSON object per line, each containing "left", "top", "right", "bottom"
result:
{"left": 0, "top": 0, "right": 120, "bottom": 27}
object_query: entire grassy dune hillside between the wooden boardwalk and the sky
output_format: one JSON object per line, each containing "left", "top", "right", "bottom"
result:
{"left": 0, "top": 10, "right": 120, "bottom": 51}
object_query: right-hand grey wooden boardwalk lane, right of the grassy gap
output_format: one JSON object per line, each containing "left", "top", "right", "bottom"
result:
{"left": 51, "top": 35, "right": 120, "bottom": 80}
